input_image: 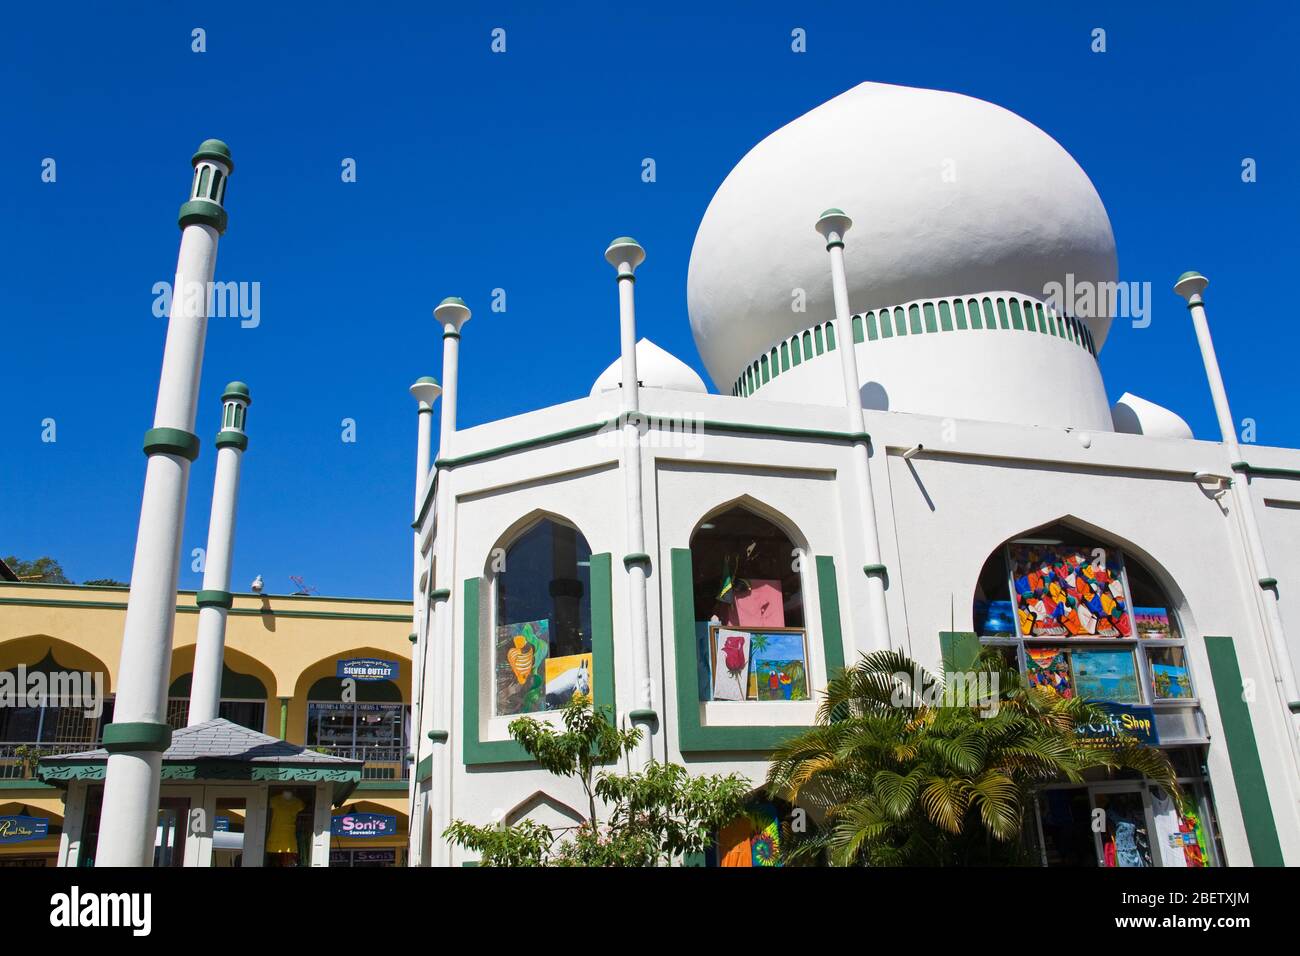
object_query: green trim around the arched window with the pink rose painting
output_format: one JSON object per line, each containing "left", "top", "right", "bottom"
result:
{"left": 671, "top": 548, "right": 844, "bottom": 753}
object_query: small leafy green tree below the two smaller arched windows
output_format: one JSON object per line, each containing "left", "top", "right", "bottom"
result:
{"left": 443, "top": 696, "right": 750, "bottom": 866}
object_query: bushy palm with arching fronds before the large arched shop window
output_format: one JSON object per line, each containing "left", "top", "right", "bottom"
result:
{"left": 767, "top": 650, "right": 1180, "bottom": 866}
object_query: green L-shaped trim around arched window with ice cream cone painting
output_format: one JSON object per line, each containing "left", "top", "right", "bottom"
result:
{"left": 462, "top": 551, "right": 613, "bottom": 766}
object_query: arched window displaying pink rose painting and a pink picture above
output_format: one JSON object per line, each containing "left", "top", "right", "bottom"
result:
{"left": 690, "top": 507, "right": 813, "bottom": 701}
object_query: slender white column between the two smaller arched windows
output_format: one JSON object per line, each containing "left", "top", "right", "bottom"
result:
{"left": 605, "top": 235, "right": 657, "bottom": 766}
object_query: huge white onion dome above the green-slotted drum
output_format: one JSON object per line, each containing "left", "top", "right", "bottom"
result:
{"left": 686, "top": 83, "right": 1115, "bottom": 394}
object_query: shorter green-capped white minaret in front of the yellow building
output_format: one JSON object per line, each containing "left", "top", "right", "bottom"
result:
{"left": 189, "top": 381, "right": 252, "bottom": 727}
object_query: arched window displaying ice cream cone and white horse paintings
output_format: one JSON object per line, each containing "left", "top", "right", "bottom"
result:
{"left": 493, "top": 518, "right": 593, "bottom": 717}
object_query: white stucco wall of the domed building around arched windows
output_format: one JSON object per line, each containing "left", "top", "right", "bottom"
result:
{"left": 421, "top": 382, "right": 1300, "bottom": 864}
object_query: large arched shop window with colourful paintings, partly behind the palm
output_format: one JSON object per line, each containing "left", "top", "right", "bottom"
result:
{"left": 974, "top": 528, "right": 1222, "bottom": 868}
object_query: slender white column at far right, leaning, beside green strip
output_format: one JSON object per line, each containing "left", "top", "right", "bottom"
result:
{"left": 1174, "top": 272, "right": 1300, "bottom": 761}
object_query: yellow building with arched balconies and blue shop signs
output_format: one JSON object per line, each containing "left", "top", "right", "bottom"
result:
{"left": 0, "top": 581, "right": 411, "bottom": 866}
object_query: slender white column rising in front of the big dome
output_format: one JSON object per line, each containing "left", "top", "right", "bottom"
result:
{"left": 816, "top": 209, "right": 893, "bottom": 649}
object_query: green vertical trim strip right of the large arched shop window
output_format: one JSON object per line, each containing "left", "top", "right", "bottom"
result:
{"left": 1205, "top": 635, "right": 1284, "bottom": 866}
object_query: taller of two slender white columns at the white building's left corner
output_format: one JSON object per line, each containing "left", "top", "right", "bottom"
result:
{"left": 426, "top": 297, "right": 477, "bottom": 866}
